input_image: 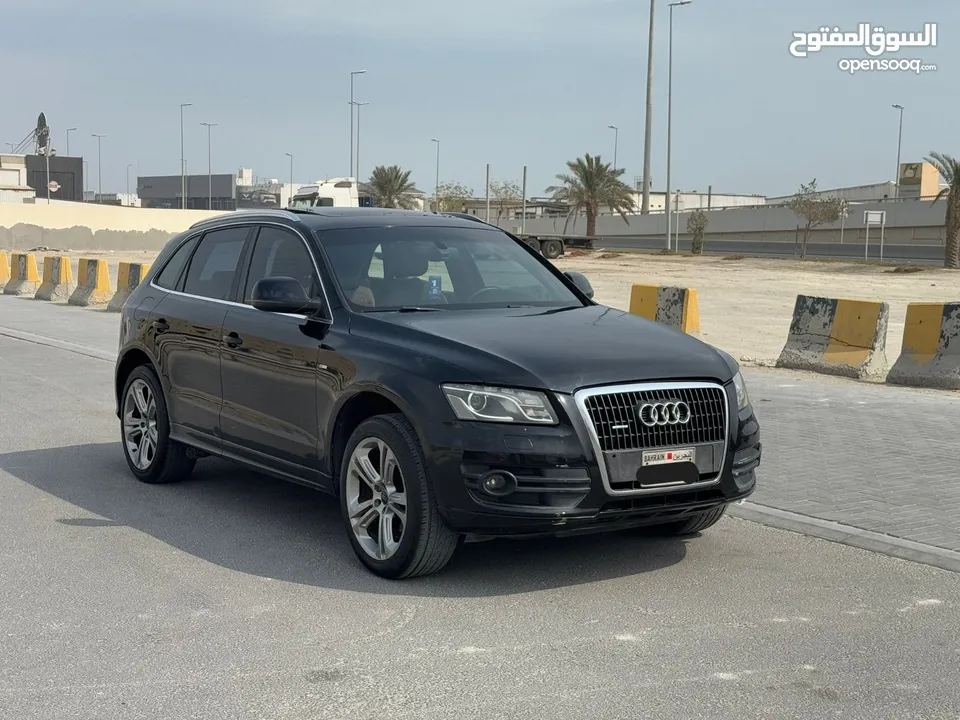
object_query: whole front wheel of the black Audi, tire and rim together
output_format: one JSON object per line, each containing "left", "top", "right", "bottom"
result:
{"left": 340, "top": 414, "right": 460, "bottom": 580}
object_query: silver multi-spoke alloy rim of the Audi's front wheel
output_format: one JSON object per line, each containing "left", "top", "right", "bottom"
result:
{"left": 346, "top": 437, "right": 407, "bottom": 560}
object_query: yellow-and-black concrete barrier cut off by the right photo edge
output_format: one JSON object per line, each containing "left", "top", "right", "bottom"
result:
{"left": 887, "top": 302, "right": 960, "bottom": 390}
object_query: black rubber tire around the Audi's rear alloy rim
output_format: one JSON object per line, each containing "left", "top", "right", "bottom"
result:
{"left": 120, "top": 365, "right": 197, "bottom": 485}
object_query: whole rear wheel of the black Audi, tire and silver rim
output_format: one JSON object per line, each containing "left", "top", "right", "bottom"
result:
{"left": 120, "top": 365, "right": 196, "bottom": 483}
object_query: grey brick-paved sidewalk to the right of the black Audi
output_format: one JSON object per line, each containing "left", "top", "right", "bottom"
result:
{"left": 744, "top": 368, "right": 960, "bottom": 551}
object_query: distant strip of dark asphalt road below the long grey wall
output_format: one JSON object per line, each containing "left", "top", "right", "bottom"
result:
{"left": 594, "top": 235, "right": 943, "bottom": 266}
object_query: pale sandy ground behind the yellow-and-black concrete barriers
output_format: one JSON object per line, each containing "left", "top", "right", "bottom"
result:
{"left": 9, "top": 251, "right": 960, "bottom": 372}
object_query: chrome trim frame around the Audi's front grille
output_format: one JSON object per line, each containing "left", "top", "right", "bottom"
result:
{"left": 573, "top": 382, "right": 730, "bottom": 497}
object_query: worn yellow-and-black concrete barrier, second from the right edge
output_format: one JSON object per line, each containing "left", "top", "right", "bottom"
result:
{"left": 777, "top": 295, "right": 890, "bottom": 380}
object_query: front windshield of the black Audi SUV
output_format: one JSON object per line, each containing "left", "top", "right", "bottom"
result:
{"left": 320, "top": 227, "right": 582, "bottom": 312}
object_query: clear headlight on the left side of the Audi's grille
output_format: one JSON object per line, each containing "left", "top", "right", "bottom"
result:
{"left": 442, "top": 385, "right": 557, "bottom": 425}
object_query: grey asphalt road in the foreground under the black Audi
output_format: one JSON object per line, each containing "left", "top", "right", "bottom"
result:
{"left": 0, "top": 298, "right": 960, "bottom": 720}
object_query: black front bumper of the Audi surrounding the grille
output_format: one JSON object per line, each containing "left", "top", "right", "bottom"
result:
{"left": 425, "top": 387, "right": 762, "bottom": 536}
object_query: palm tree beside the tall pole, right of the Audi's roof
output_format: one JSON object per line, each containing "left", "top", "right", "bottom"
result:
{"left": 547, "top": 153, "right": 636, "bottom": 237}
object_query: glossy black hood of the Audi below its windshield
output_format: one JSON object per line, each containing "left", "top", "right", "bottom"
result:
{"left": 351, "top": 305, "right": 734, "bottom": 393}
